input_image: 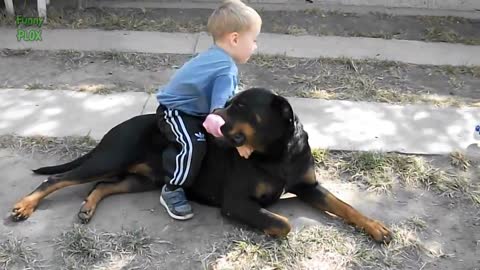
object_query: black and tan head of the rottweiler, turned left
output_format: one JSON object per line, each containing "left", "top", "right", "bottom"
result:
{"left": 214, "top": 88, "right": 295, "bottom": 153}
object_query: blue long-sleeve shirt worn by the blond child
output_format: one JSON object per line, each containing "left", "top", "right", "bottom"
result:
{"left": 156, "top": 45, "right": 238, "bottom": 116}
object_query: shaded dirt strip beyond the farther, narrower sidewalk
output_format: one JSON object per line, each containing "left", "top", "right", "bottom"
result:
{"left": 0, "top": 5, "right": 480, "bottom": 44}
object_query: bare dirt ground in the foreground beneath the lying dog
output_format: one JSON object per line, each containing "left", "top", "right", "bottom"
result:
{"left": 0, "top": 138, "right": 480, "bottom": 270}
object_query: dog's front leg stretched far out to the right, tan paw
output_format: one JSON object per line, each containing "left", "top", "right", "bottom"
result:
{"left": 290, "top": 182, "right": 392, "bottom": 243}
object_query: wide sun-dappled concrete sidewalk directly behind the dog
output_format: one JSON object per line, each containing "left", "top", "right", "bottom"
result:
{"left": 0, "top": 89, "right": 480, "bottom": 154}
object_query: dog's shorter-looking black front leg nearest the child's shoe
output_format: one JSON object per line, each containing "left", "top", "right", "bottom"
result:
{"left": 222, "top": 197, "right": 292, "bottom": 237}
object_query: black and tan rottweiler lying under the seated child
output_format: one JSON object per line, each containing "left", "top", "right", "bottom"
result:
{"left": 11, "top": 88, "right": 392, "bottom": 243}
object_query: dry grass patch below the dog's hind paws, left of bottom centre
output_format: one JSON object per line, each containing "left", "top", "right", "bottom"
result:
{"left": 55, "top": 225, "right": 170, "bottom": 269}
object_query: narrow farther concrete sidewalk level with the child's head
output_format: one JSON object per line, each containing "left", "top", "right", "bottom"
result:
{"left": 0, "top": 28, "right": 480, "bottom": 66}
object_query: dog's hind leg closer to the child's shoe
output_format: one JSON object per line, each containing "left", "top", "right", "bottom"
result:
{"left": 78, "top": 176, "right": 156, "bottom": 223}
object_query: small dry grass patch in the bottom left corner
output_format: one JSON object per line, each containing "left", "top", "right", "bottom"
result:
{"left": 0, "top": 235, "right": 45, "bottom": 269}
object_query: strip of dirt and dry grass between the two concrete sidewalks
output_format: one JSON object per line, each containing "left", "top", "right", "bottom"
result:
{"left": 0, "top": 50, "right": 480, "bottom": 106}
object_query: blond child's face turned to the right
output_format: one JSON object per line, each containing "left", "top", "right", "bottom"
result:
{"left": 233, "top": 23, "right": 261, "bottom": 64}
